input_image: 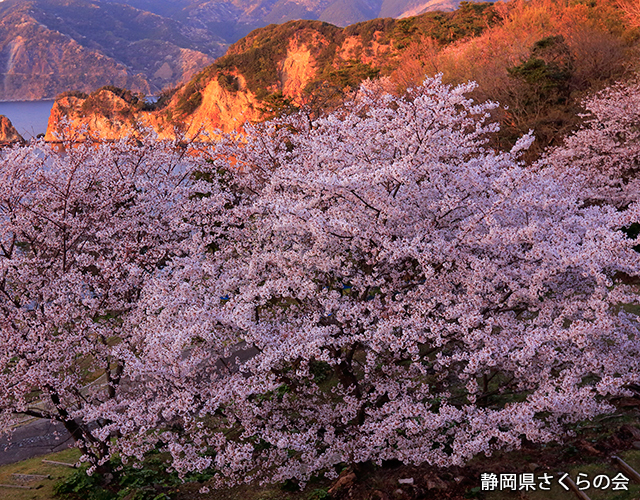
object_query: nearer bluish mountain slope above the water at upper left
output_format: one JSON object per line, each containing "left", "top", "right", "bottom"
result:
{"left": 0, "top": 0, "right": 225, "bottom": 100}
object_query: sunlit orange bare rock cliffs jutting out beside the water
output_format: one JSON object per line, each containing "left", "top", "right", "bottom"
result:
{"left": 46, "top": 21, "right": 384, "bottom": 140}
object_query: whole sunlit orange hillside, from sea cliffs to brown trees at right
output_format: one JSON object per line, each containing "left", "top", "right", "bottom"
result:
{"left": 47, "top": 0, "right": 640, "bottom": 154}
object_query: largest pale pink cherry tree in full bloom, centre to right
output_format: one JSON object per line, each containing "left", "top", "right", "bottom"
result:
{"left": 114, "top": 78, "right": 640, "bottom": 483}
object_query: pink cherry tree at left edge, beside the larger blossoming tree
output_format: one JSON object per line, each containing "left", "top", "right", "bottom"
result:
{"left": 0, "top": 133, "right": 221, "bottom": 472}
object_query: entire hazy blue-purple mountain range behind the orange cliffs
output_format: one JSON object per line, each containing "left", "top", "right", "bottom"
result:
{"left": 0, "top": 0, "right": 496, "bottom": 100}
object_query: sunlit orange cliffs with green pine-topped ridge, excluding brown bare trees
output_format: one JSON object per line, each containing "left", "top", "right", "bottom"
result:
{"left": 47, "top": 3, "right": 498, "bottom": 139}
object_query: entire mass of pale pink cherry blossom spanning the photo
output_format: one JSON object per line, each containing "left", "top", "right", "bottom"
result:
{"left": 0, "top": 78, "right": 640, "bottom": 490}
